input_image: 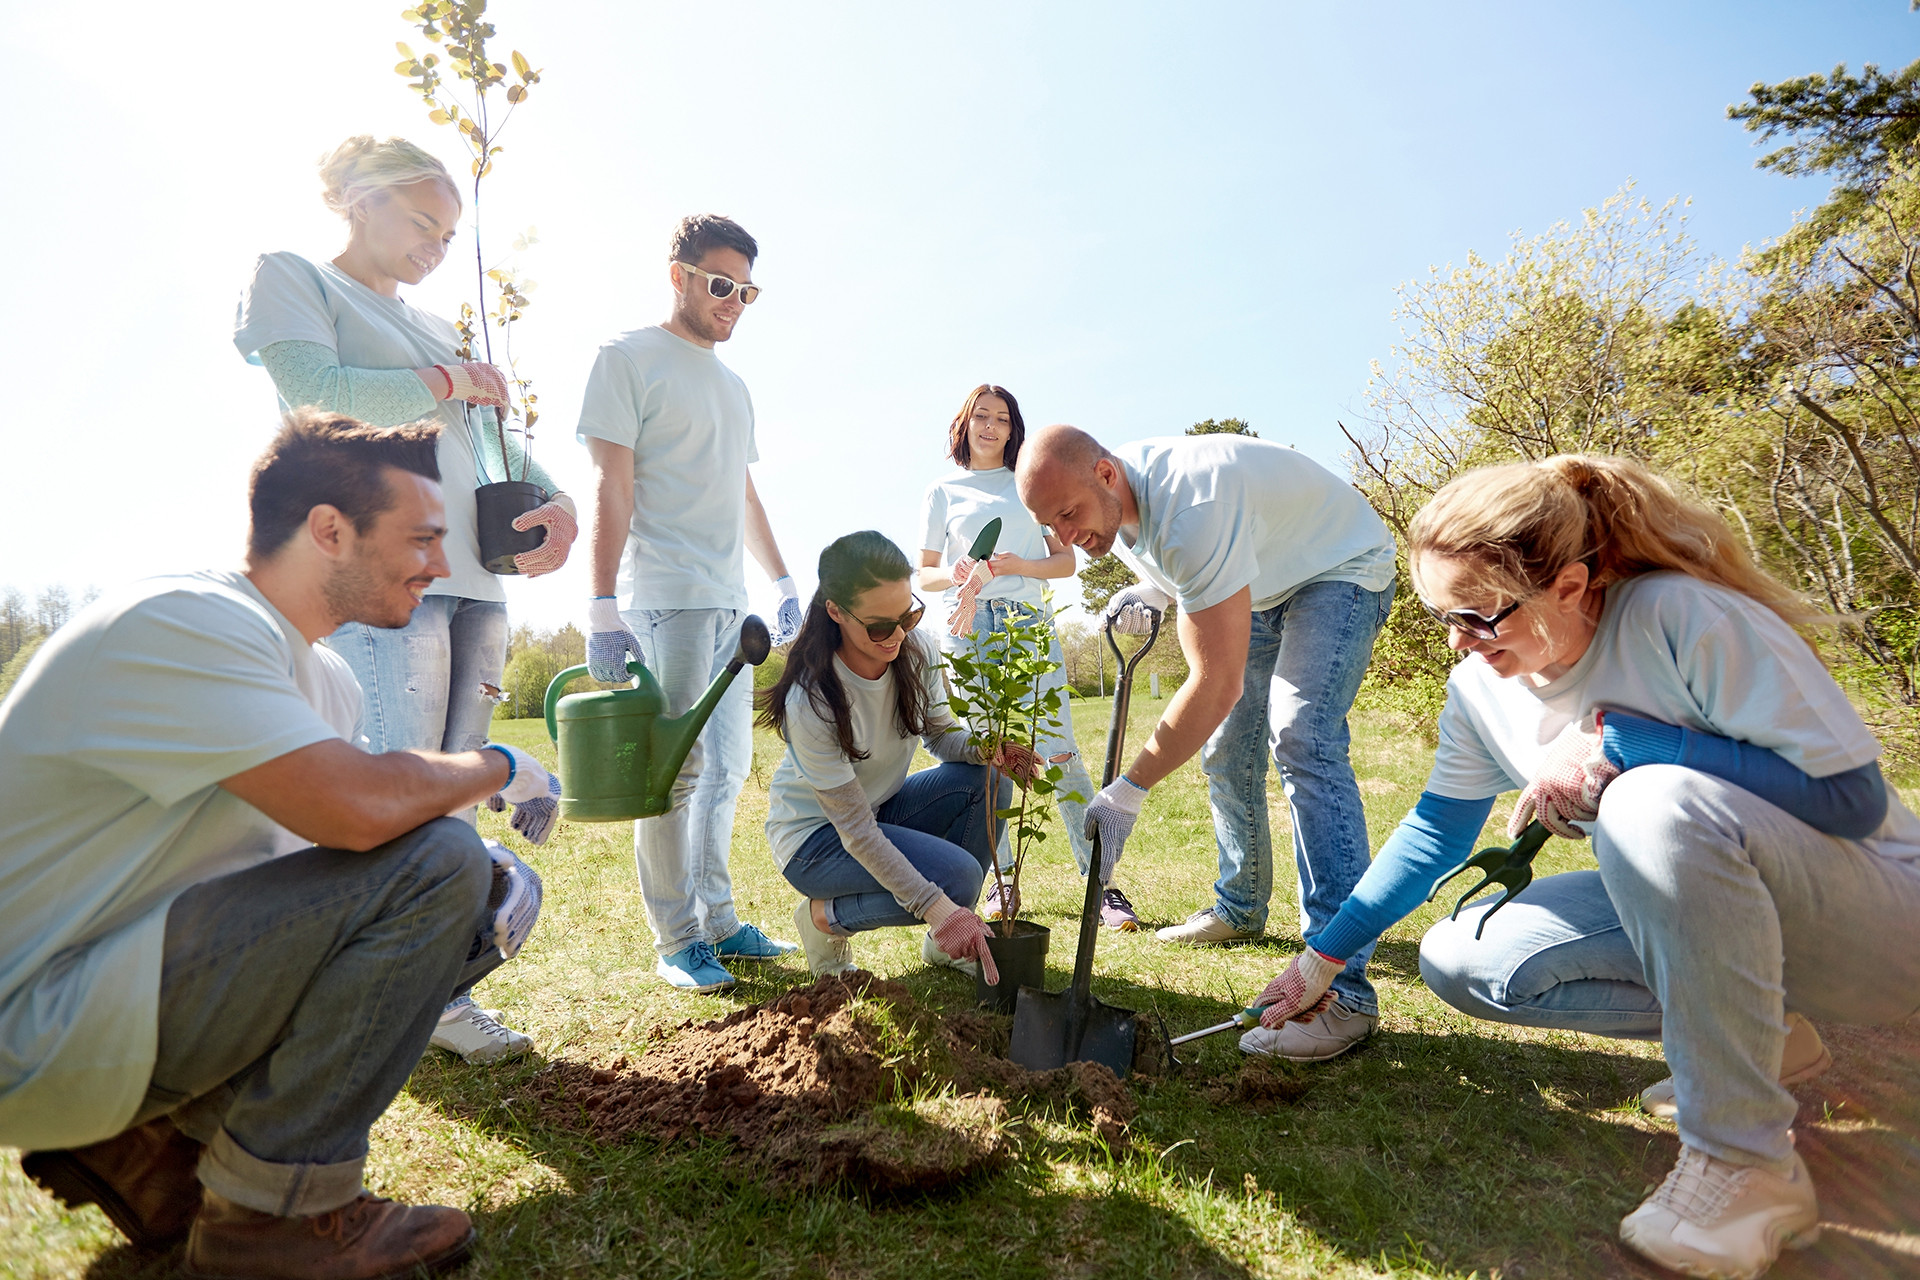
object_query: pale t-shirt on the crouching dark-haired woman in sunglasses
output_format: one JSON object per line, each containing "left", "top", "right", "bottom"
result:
{"left": 766, "top": 631, "right": 954, "bottom": 867}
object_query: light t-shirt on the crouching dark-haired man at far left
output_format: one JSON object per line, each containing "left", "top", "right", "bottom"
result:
{"left": 0, "top": 572, "right": 351, "bottom": 1148}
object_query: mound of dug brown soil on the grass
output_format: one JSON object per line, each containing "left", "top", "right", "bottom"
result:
{"left": 538, "top": 969, "right": 1135, "bottom": 1194}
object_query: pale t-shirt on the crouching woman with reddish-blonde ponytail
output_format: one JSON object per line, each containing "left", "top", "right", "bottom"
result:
{"left": 1427, "top": 572, "right": 1920, "bottom": 860}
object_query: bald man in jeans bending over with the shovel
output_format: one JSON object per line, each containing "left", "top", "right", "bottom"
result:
{"left": 1016, "top": 426, "right": 1394, "bottom": 1061}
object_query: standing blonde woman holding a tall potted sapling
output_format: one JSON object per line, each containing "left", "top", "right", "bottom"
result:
{"left": 234, "top": 134, "right": 578, "bottom": 1061}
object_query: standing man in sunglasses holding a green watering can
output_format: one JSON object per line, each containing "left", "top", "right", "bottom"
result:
{"left": 580, "top": 213, "right": 801, "bottom": 992}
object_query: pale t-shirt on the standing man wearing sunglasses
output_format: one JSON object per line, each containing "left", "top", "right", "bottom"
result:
{"left": 578, "top": 324, "right": 760, "bottom": 608}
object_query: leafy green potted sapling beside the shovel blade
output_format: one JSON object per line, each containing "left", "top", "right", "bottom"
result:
{"left": 947, "top": 594, "right": 1087, "bottom": 1013}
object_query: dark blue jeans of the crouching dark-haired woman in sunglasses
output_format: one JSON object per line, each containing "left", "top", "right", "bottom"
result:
{"left": 781, "top": 764, "right": 1014, "bottom": 933}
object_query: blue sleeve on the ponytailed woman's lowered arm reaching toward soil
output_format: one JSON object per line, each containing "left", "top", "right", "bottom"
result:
{"left": 1308, "top": 791, "right": 1494, "bottom": 960}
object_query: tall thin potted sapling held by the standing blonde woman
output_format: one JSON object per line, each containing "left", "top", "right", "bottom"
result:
{"left": 394, "top": 0, "right": 553, "bottom": 574}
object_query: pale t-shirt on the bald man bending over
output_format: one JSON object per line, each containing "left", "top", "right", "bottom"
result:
{"left": 1112, "top": 434, "right": 1394, "bottom": 614}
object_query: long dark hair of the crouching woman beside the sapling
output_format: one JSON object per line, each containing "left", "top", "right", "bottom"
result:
{"left": 755, "top": 530, "right": 929, "bottom": 760}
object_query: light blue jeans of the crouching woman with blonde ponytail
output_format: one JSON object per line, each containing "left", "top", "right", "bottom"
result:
{"left": 1421, "top": 764, "right": 1920, "bottom": 1171}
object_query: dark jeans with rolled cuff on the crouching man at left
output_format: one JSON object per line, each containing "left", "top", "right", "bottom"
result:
{"left": 134, "top": 818, "right": 499, "bottom": 1217}
